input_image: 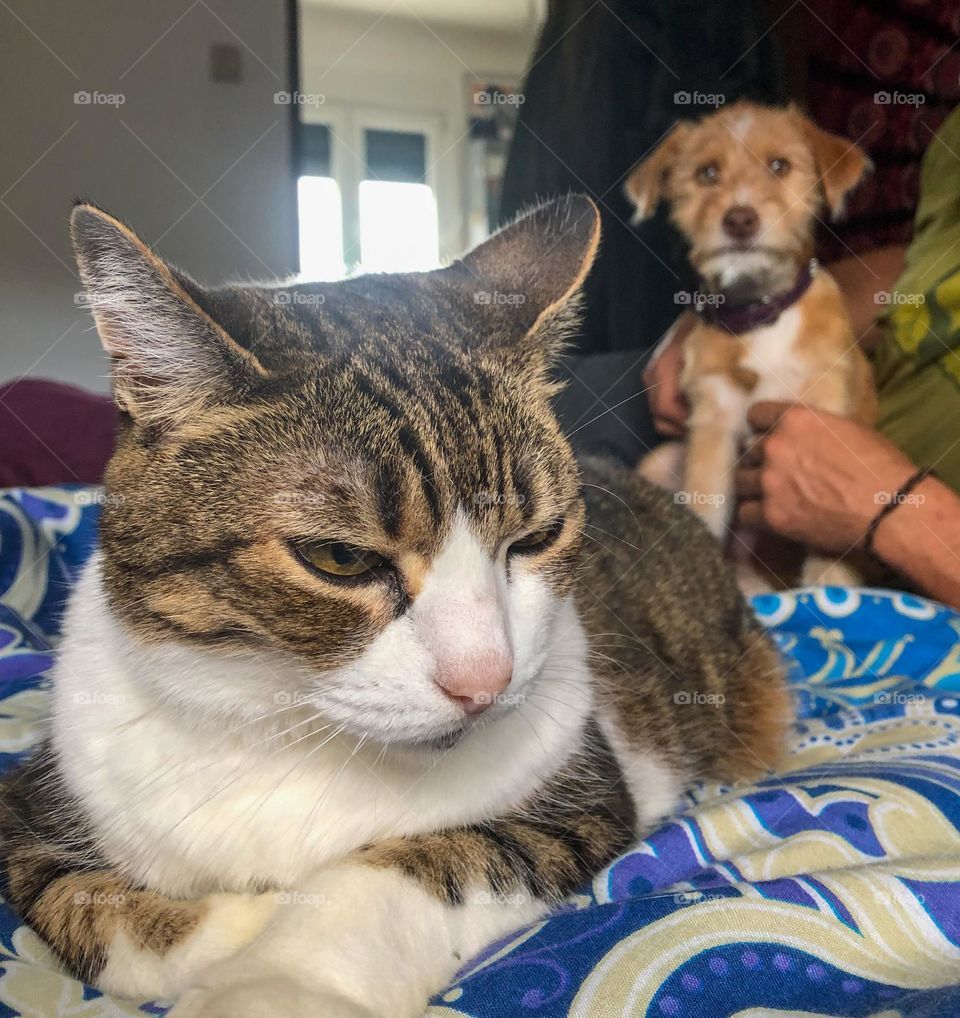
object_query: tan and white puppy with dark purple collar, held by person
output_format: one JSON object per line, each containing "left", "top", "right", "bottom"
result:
{"left": 626, "top": 102, "right": 877, "bottom": 592}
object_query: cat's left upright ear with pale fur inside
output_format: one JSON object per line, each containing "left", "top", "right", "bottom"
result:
{"left": 70, "top": 204, "right": 267, "bottom": 427}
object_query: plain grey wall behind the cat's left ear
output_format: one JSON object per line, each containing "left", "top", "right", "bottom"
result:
{"left": 0, "top": 0, "right": 296, "bottom": 389}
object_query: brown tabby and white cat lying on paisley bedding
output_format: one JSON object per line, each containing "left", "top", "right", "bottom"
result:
{"left": 2, "top": 195, "right": 791, "bottom": 1018}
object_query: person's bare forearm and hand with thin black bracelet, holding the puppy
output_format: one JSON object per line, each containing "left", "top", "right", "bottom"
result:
{"left": 737, "top": 403, "right": 960, "bottom": 607}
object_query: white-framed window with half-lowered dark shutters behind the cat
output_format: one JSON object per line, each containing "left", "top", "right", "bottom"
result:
{"left": 297, "top": 117, "right": 440, "bottom": 280}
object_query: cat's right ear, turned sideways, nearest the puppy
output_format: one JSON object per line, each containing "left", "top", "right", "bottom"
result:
{"left": 446, "top": 194, "right": 600, "bottom": 357}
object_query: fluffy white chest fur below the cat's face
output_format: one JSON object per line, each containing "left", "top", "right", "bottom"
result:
{"left": 52, "top": 567, "right": 592, "bottom": 897}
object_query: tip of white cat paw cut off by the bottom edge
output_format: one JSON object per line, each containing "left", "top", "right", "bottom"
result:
{"left": 167, "top": 977, "right": 372, "bottom": 1018}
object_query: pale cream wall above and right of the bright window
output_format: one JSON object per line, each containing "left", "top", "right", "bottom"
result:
{"left": 300, "top": 0, "right": 537, "bottom": 261}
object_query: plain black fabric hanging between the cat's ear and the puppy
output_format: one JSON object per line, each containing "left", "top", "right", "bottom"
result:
{"left": 501, "top": 0, "right": 785, "bottom": 462}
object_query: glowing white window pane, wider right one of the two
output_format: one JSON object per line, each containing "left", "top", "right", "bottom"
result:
{"left": 360, "top": 180, "right": 440, "bottom": 272}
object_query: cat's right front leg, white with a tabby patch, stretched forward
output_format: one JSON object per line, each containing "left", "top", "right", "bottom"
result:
{"left": 171, "top": 825, "right": 583, "bottom": 1018}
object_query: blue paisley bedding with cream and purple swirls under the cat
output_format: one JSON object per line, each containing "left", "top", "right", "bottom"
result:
{"left": 0, "top": 488, "right": 960, "bottom": 1018}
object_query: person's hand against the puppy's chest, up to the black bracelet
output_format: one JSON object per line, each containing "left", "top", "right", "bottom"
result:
{"left": 736, "top": 402, "right": 916, "bottom": 553}
